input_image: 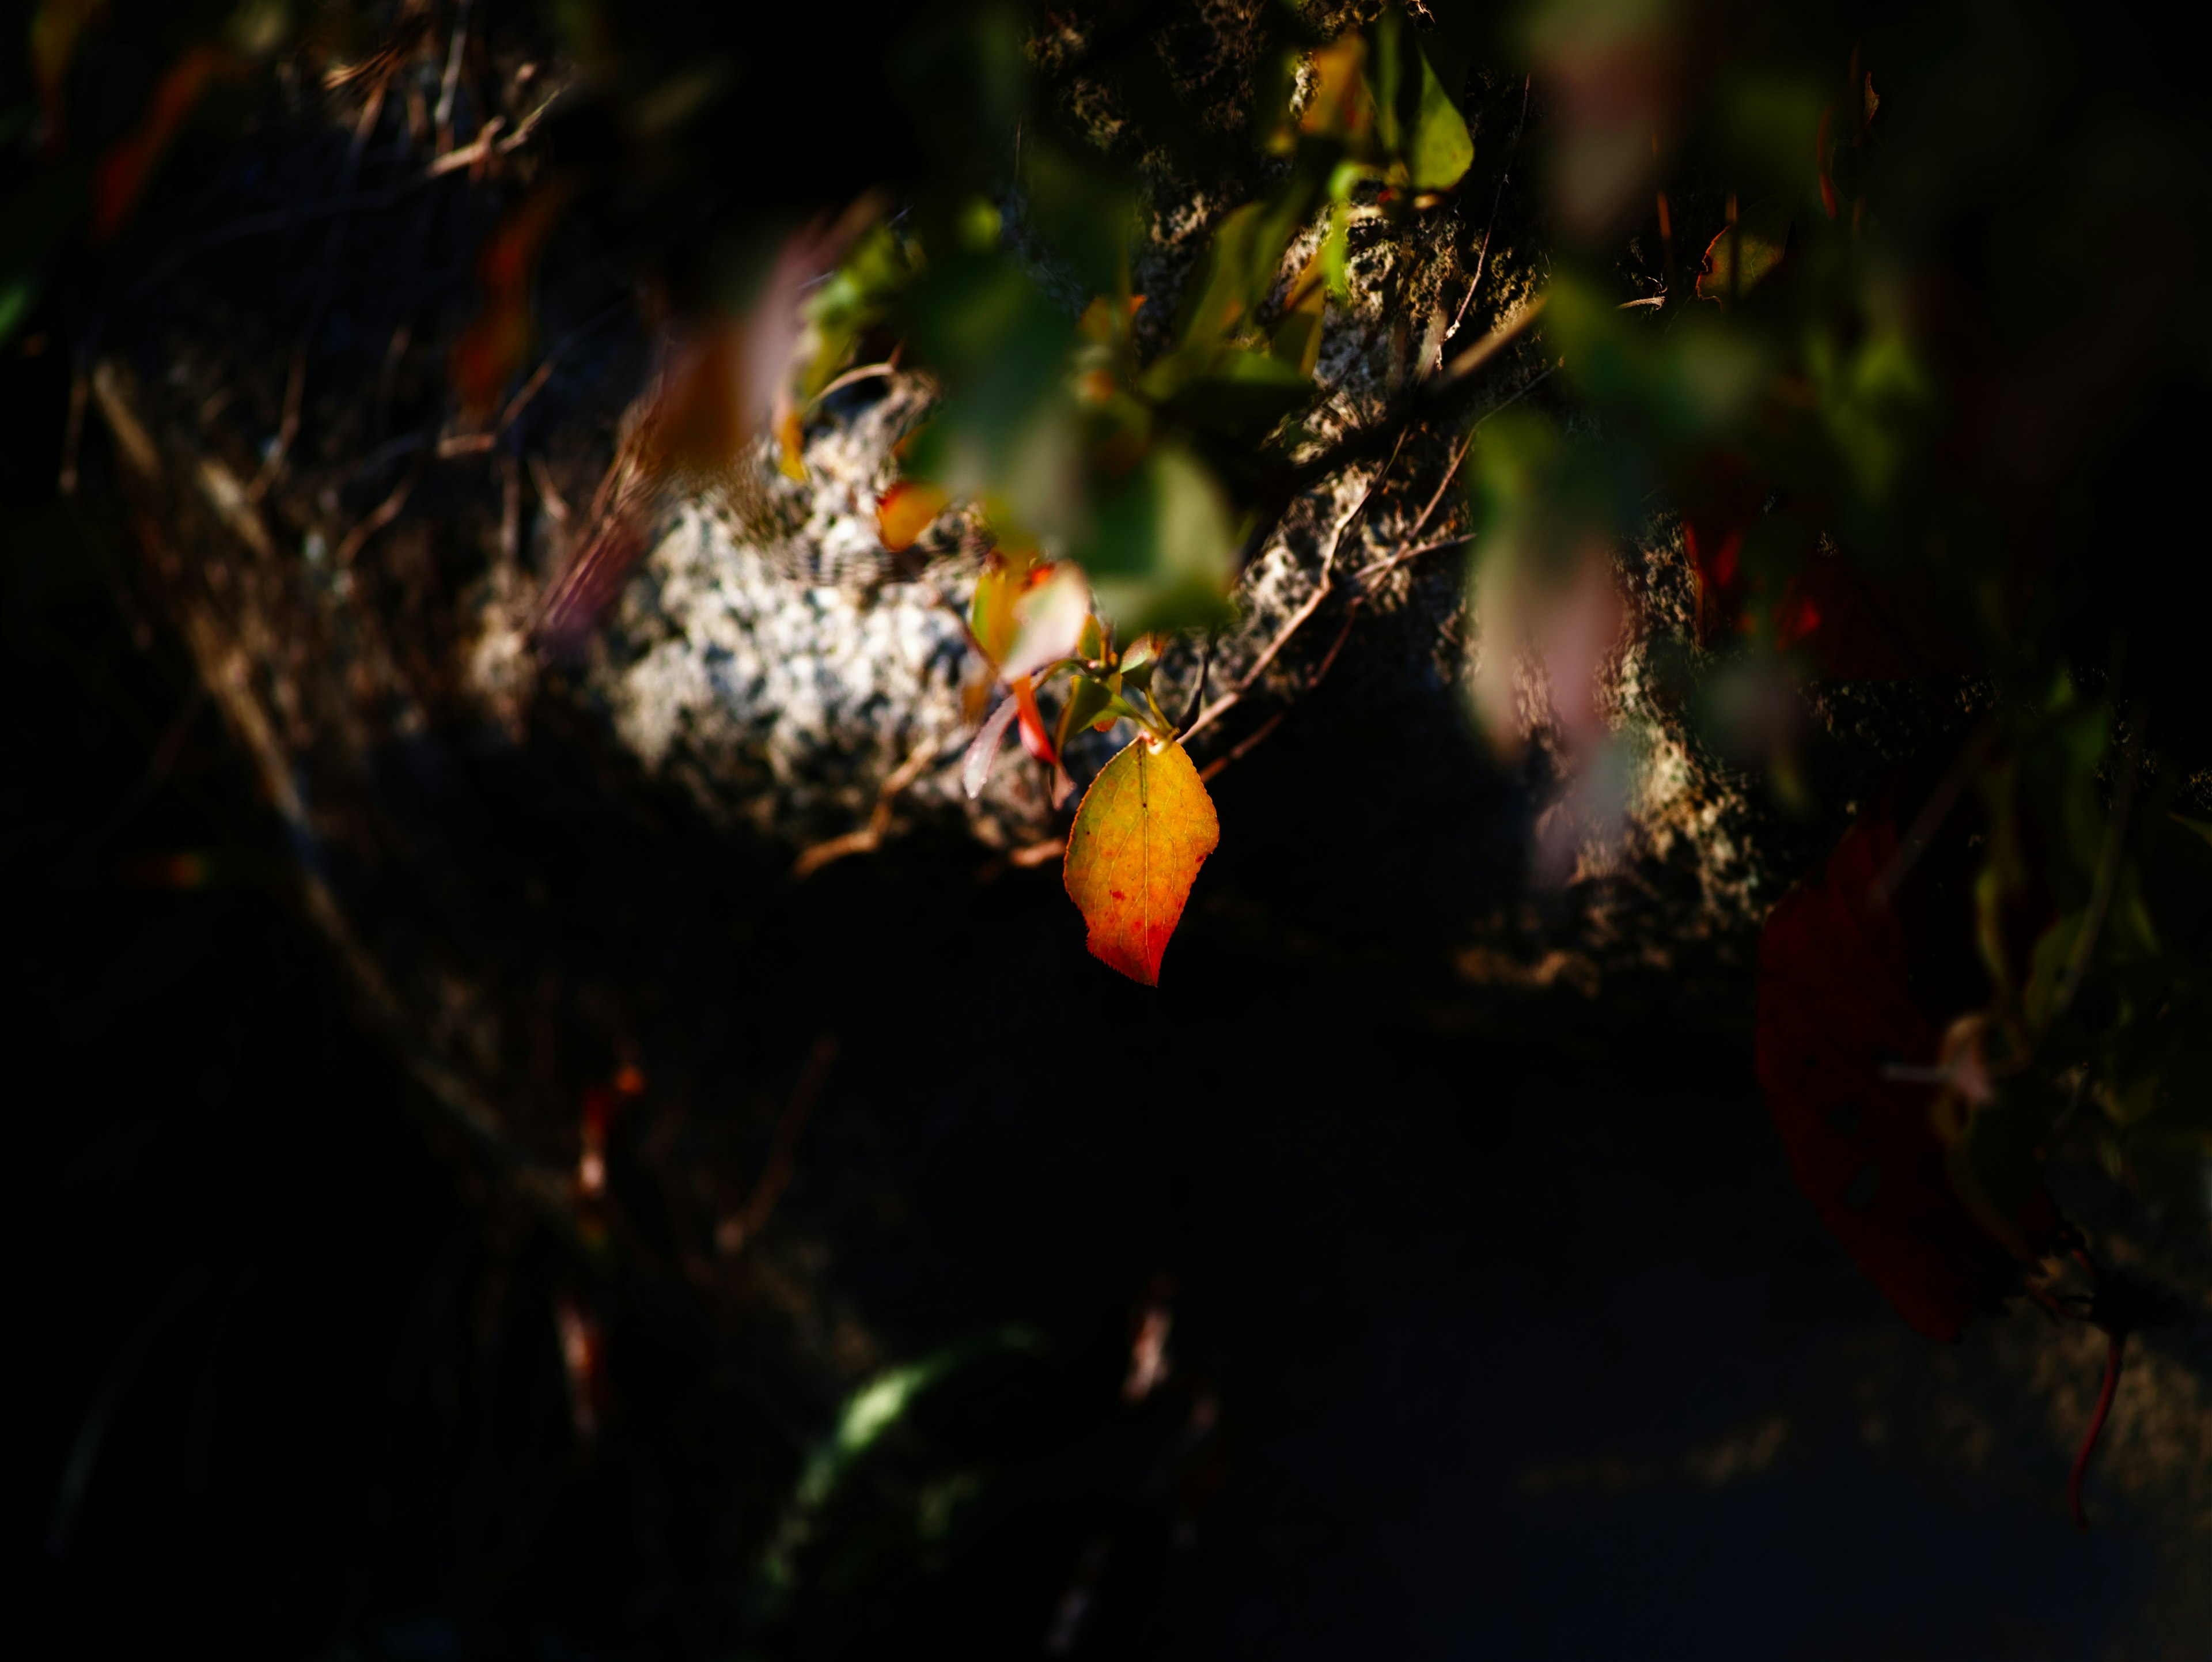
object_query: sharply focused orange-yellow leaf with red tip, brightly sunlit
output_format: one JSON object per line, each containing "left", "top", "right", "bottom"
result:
{"left": 1064, "top": 735, "right": 1221, "bottom": 987}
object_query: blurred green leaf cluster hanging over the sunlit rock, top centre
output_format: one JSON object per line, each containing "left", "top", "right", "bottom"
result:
{"left": 798, "top": 9, "right": 1473, "bottom": 639}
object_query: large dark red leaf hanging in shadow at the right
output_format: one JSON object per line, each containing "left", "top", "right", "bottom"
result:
{"left": 1756, "top": 792, "right": 2057, "bottom": 1339}
